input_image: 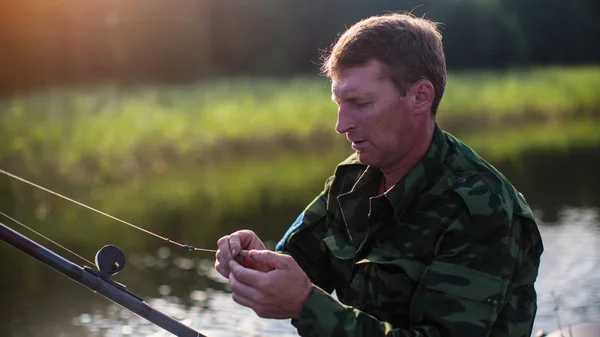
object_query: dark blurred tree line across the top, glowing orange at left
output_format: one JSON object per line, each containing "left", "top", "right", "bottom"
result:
{"left": 0, "top": 0, "right": 600, "bottom": 94}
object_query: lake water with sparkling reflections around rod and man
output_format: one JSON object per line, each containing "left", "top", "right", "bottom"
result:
{"left": 0, "top": 147, "right": 600, "bottom": 337}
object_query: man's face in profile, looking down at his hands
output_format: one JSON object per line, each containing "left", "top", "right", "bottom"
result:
{"left": 331, "top": 60, "right": 423, "bottom": 169}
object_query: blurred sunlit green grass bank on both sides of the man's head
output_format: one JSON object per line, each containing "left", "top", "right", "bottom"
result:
{"left": 0, "top": 66, "right": 600, "bottom": 180}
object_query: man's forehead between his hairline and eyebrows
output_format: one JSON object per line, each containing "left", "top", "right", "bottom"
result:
{"left": 331, "top": 60, "right": 391, "bottom": 98}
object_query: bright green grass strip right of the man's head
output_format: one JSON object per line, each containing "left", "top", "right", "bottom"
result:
{"left": 440, "top": 66, "right": 600, "bottom": 119}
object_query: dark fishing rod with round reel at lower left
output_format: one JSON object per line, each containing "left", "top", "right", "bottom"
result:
{"left": 0, "top": 223, "right": 206, "bottom": 337}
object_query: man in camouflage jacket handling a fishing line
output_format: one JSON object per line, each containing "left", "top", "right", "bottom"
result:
{"left": 215, "top": 14, "right": 543, "bottom": 337}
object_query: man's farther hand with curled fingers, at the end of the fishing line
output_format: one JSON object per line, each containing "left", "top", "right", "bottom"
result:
{"left": 215, "top": 229, "right": 266, "bottom": 278}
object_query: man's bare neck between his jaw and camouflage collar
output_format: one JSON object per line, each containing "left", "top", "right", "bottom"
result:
{"left": 381, "top": 121, "right": 434, "bottom": 191}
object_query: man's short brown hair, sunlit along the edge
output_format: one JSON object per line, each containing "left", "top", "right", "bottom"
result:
{"left": 321, "top": 13, "right": 446, "bottom": 115}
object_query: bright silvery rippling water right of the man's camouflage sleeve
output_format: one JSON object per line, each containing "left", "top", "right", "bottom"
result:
{"left": 534, "top": 208, "right": 600, "bottom": 331}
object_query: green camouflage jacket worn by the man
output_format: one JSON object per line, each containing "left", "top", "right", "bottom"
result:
{"left": 276, "top": 125, "right": 543, "bottom": 337}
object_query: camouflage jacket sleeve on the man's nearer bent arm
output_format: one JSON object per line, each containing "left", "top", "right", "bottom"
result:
{"left": 292, "top": 185, "right": 537, "bottom": 337}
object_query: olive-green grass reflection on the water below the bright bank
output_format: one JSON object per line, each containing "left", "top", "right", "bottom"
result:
{"left": 0, "top": 119, "right": 600, "bottom": 254}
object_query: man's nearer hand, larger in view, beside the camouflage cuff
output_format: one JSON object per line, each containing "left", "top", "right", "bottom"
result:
{"left": 229, "top": 250, "right": 313, "bottom": 319}
